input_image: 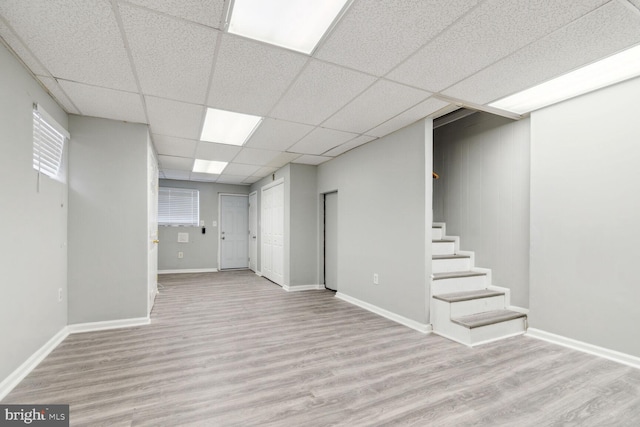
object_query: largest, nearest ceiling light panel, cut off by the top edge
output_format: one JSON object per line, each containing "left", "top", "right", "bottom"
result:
{"left": 228, "top": 0, "right": 349, "bottom": 54}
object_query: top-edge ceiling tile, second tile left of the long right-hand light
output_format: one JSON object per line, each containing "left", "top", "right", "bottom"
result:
{"left": 387, "top": 0, "right": 607, "bottom": 92}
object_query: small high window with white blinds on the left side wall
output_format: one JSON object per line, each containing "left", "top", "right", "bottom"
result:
{"left": 33, "top": 105, "right": 69, "bottom": 179}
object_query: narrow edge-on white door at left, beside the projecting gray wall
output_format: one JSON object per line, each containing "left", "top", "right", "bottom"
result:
{"left": 147, "top": 147, "right": 158, "bottom": 314}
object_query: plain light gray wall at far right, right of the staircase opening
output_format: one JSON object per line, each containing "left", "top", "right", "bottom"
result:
{"left": 530, "top": 79, "right": 640, "bottom": 357}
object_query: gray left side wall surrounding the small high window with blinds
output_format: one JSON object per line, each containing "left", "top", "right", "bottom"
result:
{"left": 0, "top": 42, "right": 67, "bottom": 382}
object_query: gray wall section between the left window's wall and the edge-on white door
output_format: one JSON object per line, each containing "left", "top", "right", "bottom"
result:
{"left": 69, "top": 116, "right": 149, "bottom": 324}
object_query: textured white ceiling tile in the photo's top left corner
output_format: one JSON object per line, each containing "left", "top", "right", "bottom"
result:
{"left": 0, "top": 0, "right": 137, "bottom": 91}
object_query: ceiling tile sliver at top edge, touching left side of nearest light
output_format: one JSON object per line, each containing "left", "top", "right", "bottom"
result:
{"left": 124, "top": 0, "right": 224, "bottom": 28}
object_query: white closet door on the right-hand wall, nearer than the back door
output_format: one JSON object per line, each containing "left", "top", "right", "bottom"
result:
{"left": 261, "top": 182, "right": 284, "bottom": 285}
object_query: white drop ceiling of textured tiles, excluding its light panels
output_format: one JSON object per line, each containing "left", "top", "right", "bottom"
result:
{"left": 0, "top": 0, "right": 640, "bottom": 184}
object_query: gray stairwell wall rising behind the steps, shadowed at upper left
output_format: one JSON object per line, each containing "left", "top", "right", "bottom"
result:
{"left": 433, "top": 113, "right": 530, "bottom": 307}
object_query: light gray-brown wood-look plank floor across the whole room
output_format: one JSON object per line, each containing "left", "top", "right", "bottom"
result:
{"left": 3, "top": 271, "right": 640, "bottom": 427}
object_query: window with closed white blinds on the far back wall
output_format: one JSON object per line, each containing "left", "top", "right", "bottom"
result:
{"left": 158, "top": 187, "right": 200, "bottom": 227}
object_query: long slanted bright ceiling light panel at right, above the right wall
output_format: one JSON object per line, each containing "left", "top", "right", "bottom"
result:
{"left": 489, "top": 45, "right": 640, "bottom": 114}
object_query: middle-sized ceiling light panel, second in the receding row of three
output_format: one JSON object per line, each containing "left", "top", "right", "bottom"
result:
{"left": 200, "top": 108, "right": 262, "bottom": 145}
